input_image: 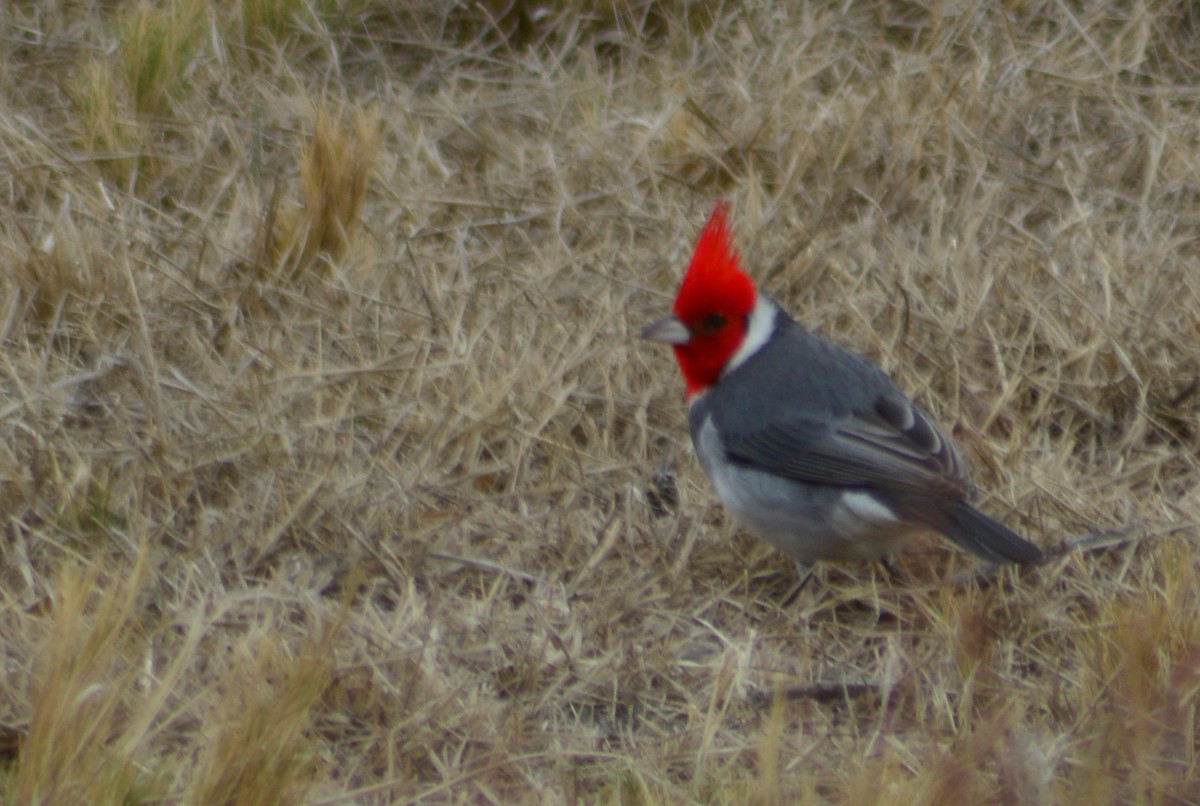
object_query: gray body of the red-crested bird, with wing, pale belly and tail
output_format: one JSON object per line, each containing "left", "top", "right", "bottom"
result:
{"left": 689, "top": 297, "right": 1042, "bottom": 565}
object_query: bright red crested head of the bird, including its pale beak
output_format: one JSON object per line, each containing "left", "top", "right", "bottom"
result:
{"left": 642, "top": 202, "right": 757, "bottom": 397}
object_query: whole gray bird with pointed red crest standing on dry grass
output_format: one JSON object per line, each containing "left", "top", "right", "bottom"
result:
{"left": 641, "top": 200, "right": 1043, "bottom": 582}
